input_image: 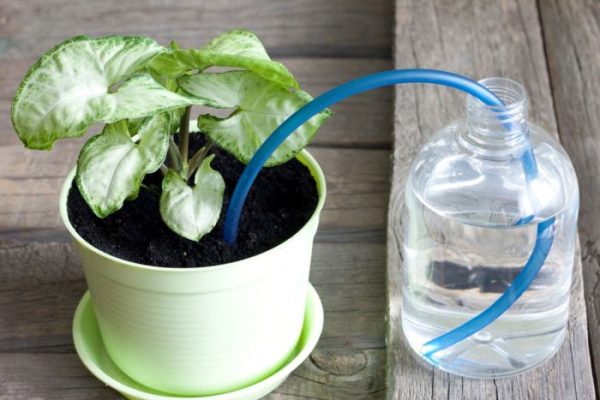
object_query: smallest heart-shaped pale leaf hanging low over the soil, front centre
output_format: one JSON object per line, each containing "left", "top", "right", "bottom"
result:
{"left": 160, "top": 154, "right": 225, "bottom": 241}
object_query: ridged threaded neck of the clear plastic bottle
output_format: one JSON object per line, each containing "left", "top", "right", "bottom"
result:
{"left": 460, "top": 78, "right": 529, "bottom": 159}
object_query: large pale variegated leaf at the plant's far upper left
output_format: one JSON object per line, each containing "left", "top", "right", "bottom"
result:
{"left": 11, "top": 36, "right": 164, "bottom": 149}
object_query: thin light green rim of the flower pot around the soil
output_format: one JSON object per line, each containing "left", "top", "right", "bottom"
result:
{"left": 59, "top": 150, "right": 327, "bottom": 273}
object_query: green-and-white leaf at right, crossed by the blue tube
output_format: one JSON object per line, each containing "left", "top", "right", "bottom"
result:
{"left": 178, "top": 71, "right": 331, "bottom": 166}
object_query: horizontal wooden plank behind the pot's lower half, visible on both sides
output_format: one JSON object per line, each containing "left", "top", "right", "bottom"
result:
{"left": 0, "top": 241, "right": 385, "bottom": 352}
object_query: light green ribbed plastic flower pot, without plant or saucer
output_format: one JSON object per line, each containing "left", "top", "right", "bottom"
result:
{"left": 60, "top": 151, "right": 326, "bottom": 396}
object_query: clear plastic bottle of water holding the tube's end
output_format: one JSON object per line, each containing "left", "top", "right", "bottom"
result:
{"left": 399, "top": 78, "right": 579, "bottom": 378}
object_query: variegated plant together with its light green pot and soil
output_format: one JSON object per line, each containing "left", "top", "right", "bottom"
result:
{"left": 11, "top": 29, "right": 329, "bottom": 395}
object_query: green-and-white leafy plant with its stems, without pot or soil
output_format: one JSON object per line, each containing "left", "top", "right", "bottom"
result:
{"left": 11, "top": 29, "right": 329, "bottom": 241}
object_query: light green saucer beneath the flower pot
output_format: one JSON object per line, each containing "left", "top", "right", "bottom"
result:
{"left": 73, "top": 285, "right": 323, "bottom": 400}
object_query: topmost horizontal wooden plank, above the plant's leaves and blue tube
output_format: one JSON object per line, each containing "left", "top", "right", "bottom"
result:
{"left": 0, "top": 0, "right": 394, "bottom": 61}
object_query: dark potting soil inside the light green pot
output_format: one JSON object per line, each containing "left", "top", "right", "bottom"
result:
{"left": 67, "top": 133, "right": 318, "bottom": 267}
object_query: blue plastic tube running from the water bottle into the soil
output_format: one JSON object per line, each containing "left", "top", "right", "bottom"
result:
{"left": 224, "top": 69, "right": 554, "bottom": 361}
